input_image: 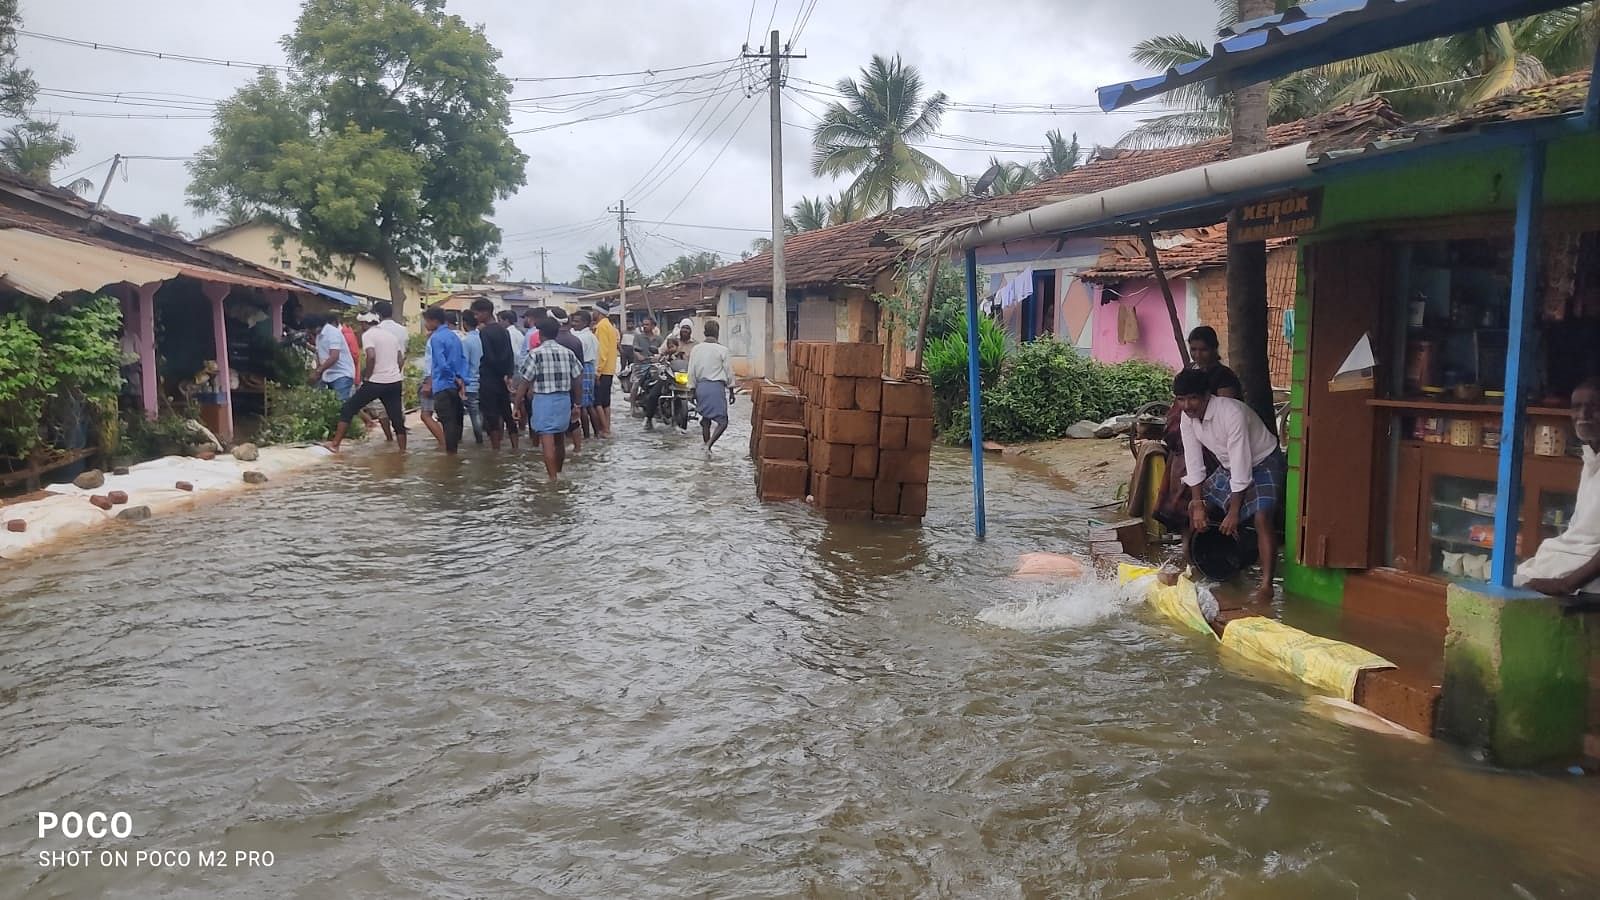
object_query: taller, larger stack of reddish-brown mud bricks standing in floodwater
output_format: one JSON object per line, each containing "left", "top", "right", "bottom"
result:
{"left": 789, "top": 343, "right": 933, "bottom": 520}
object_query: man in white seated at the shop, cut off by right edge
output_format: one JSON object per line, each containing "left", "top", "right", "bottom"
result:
{"left": 1517, "top": 378, "right": 1600, "bottom": 602}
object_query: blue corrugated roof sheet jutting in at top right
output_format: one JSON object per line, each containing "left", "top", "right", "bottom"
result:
{"left": 1098, "top": 0, "right": 1571, "bottom": 112}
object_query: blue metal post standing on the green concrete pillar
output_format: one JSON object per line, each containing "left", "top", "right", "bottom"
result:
{"left": 1490, "top": 143, "right": 1544, "bottom": 588}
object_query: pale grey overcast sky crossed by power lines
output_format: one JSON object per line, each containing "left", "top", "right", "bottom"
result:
{"left": 18, "top": 0, "right": 1216, "bottom": 280}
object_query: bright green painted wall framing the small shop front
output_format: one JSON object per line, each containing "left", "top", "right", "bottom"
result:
{"left": 1283, "top": 135, "right": 1600, "bottom": 604}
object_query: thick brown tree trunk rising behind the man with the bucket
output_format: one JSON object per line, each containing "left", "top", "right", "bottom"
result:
{"left": 1227, "top": 0, "right": 1277, "bottom": 431}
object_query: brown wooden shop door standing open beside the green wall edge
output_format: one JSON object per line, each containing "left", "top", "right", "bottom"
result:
{"left": 1299, "top": 240, "right": 1390, "bottom": 569}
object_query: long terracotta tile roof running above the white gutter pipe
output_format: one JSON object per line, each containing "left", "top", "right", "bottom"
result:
{"left": 706, "top": 98, "right": 1402, "bottom": 296}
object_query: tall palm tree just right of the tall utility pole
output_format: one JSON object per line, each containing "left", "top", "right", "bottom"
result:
{"left": 811, "top": 54, "right": 949, "bottom": 213}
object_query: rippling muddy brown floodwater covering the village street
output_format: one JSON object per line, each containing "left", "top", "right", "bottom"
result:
{"left": 0, "top": 416, "right": 1600, "bottom": 898}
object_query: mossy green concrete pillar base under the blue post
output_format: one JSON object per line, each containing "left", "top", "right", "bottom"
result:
{"left": 1438, "top": 585, "right": 1589, "bottom": 767}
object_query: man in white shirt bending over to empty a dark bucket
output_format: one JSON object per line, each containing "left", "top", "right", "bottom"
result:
{"left": 1173, "top": 368, "right": 1286, "bottom": 602}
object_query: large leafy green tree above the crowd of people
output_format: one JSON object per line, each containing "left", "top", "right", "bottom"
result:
{"left": 189, "top": 0, "right": 526, "bottom": 315}
